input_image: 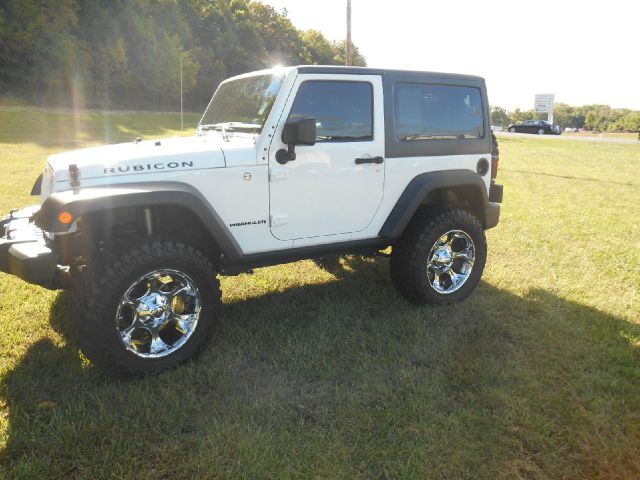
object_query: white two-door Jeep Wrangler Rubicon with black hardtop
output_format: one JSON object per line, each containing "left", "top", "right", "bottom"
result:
{"left": 0, "top": 66, "right": 502, "bottom": 375}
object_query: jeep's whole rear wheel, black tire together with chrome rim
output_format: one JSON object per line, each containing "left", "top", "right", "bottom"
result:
{"left": 390, "top": 208, "right": 487, "bottom": 305}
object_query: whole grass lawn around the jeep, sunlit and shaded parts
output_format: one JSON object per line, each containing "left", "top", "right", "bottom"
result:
{"left": 0, "top": 108, "right": 640, "bottom": 479}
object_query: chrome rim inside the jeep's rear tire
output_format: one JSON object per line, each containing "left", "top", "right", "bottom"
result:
{"left": 427, "top": 230, "right": 476, "bottom": 294}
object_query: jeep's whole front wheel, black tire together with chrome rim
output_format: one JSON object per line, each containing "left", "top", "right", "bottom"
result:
{"left": 79, "top": 240, "right": 221, "bottom": 377}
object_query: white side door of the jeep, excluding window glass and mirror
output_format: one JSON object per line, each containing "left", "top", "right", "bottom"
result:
{"left": 269, "top": 74, "right": 385, "bottom": 242}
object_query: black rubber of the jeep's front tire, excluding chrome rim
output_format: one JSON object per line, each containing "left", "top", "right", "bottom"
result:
{"left": 73, "top": 240, "right": 222, "bottom": 377}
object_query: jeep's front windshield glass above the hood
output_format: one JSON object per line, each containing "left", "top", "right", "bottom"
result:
{"left": 200, "top": 75, "right": 282, "bottom": 133}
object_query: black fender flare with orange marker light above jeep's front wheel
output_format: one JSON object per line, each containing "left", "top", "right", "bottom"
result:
{"left": 34, "top": 182, "right": 242, "bottom": 260}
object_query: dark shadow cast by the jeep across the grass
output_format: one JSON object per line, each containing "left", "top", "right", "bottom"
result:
{"left": 1, "top": 258, "right": 640, "bottom": 478}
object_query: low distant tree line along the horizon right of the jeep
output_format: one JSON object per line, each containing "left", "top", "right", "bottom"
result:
{"left": 491, "top": 103, "right": 640, "bottom": 132}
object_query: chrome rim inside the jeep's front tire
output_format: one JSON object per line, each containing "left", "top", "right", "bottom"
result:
{"left": 116, "top": 269, "right": 202, "bottom": 358}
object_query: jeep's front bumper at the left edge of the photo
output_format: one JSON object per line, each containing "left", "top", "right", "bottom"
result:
{"left": 0, "top": 205, "right": 58, "bottom": 288}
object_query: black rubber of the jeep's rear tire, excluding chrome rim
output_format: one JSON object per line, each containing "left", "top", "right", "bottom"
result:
{"left": 390, "top": 207, "right": 487, "bottom": 305}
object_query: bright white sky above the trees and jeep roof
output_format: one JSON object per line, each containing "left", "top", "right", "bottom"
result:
{"left": 261, "top": 0, "right": 640, "bottom": 110}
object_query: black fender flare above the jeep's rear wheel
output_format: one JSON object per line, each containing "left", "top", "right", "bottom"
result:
{"left": 378, "top": 170, "right": 491, "bottom": 238}
